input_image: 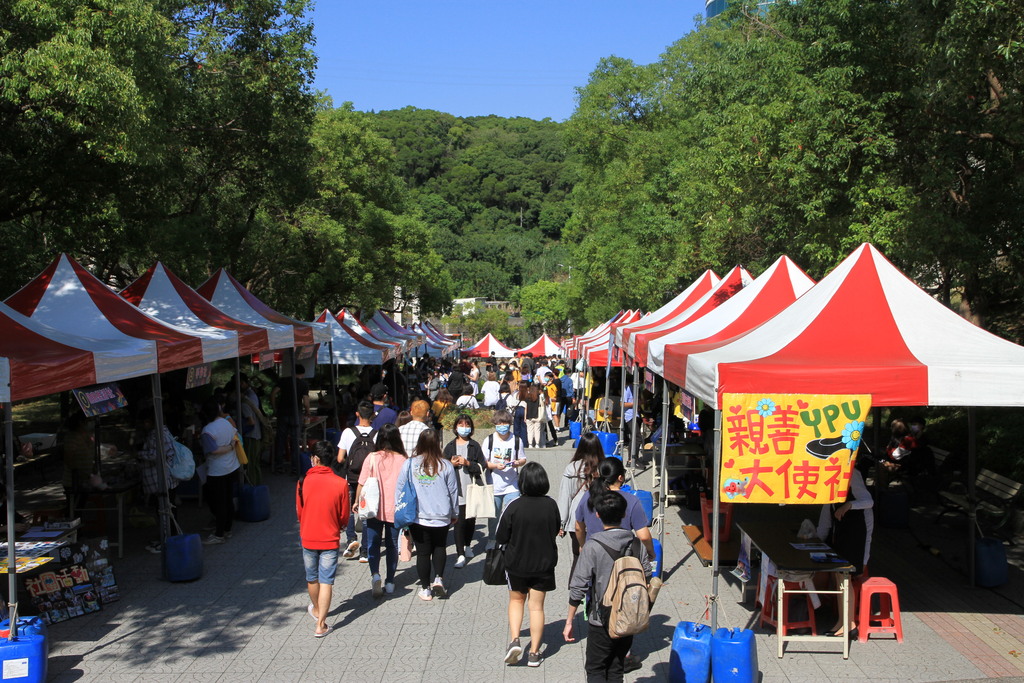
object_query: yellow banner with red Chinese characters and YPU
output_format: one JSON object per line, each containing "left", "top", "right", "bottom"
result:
{"left": 719, "top": 393, "right": 871, "bottom": 505}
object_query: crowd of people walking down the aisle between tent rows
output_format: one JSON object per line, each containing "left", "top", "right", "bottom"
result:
{"left": 296, "top": 352, "right": 654, "bottom": 681}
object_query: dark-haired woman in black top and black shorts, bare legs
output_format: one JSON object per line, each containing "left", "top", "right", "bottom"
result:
{"left": 496, "top": 463, "right": 559, "bottom": 667}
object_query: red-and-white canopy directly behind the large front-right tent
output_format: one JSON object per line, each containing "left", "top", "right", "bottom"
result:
{"left": 647, "top": 256, "right": 814, "bottom": 376}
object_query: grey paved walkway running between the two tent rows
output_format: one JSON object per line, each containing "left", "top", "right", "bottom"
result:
{"left": 39, "top": 436, "right": 1024, "bottom": 683}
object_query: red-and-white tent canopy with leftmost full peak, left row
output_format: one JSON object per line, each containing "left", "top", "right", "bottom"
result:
{"left": 6, "top": 254, "right": 207, "bottom": 375}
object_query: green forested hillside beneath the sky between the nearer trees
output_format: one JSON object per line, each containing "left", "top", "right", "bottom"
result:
{"left": 374, "top": 106, "right": 571, "bottom": 299}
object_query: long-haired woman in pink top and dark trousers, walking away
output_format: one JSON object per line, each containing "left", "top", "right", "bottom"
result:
{"left": 352, "top": 424, "right": 406, "bottom": 598}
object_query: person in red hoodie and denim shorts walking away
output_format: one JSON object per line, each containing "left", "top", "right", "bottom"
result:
{"left": 295, "top": 441, "right": 349, "bottom": 638}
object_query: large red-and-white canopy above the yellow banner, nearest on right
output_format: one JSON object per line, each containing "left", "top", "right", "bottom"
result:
{"left": 666, "top": 244, "right": 1024, "bottom": 407}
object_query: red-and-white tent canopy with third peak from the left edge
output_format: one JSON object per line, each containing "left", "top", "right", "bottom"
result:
{"left": 121, "top": 262, "right": 270, "bottom": 360}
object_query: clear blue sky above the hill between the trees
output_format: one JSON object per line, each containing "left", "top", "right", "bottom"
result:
{"left": 312, "top": 0, "right": 705, "bottom": 121}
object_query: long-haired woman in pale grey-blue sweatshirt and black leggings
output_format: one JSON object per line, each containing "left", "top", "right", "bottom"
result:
{"left": 396, "top": 429, "right": 459, "bottom": 600}
